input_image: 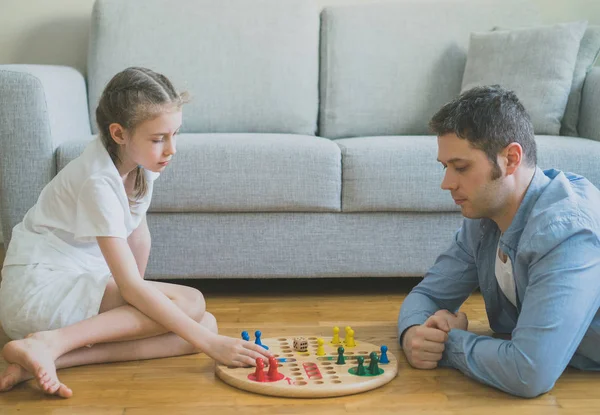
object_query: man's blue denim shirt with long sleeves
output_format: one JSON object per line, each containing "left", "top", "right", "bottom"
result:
{"left": 398, "top": 168, "right": 600, "bottom": 397}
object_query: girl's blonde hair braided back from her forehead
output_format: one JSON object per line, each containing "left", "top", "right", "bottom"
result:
{"left": 96, "top": 67, "right": 189, "bottom": 200}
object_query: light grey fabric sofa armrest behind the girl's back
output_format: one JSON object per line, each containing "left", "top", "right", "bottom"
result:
{"left": 0, "top": 65, "right": 91, "bottom": 246}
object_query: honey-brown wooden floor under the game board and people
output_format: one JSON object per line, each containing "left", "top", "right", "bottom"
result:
{"left": 0, "top": 245, "right": 600, "bottom": 415}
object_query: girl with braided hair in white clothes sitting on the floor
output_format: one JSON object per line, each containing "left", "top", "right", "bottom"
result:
{"left": 0, "top": 68, "right": 270, "bottom": 398}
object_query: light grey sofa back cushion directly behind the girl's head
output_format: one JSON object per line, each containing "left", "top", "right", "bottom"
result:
{"left": 88, "top": 0, "right": 320, "bottom": 135}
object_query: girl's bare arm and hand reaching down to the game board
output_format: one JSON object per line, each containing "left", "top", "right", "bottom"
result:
{"left": 97, "top": 237, "right": 270, "bottom": 366}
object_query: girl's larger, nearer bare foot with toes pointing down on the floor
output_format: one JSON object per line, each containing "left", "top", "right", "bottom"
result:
{"left": 2, "top": 332, "right": 73, "bottom": 398}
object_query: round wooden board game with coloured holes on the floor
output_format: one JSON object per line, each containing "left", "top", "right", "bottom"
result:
{"left": 215, "top": 336, "right": 398, "bottom": 398}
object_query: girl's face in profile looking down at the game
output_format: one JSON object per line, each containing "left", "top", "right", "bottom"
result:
{"left": 111, "top": 109, "right": 182, "bottom": 177}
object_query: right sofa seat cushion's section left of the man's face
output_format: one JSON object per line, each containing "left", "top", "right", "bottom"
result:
{"left": 335, "top": 136, "right": 450, "bottom": 212}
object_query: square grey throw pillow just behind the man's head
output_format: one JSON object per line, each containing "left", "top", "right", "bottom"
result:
{"left": 461, "top": 22, "right": 587, "bottom": 135}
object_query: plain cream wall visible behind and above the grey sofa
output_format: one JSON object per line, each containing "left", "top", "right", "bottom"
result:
{"left": 0, "top": 0, "right": 600, "bottom": 241}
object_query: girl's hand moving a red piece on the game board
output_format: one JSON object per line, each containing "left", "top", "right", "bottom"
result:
{"left": 204, "top": 335, "right": 271, "bottom": 367}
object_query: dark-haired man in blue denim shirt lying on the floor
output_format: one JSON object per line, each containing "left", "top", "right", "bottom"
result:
{"left": 398, "top": 86, "right": 600, "bottom": 397}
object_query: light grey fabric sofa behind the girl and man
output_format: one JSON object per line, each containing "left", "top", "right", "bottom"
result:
{"left": 0, "top": 0, "right": 600, "bottom": 278}
